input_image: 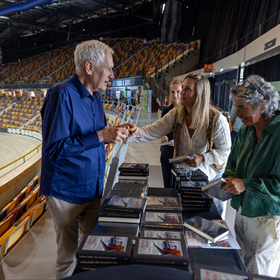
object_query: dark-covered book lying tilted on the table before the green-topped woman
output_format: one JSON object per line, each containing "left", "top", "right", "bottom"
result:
{"left": 184, "top": 216, "right": 229, "bottom": 242}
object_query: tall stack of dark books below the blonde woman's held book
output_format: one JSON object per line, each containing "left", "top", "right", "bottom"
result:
{"left": 179, "top": 181, "right": 213, "bottom": 212}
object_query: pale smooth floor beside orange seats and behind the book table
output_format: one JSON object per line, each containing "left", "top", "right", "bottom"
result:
{"left": 0, "top": 112, "right": 280, "bottom": 280}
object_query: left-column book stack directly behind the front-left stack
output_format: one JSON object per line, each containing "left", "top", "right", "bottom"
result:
{"left": 98, "top": 188, "right": 147, "bottom": 224}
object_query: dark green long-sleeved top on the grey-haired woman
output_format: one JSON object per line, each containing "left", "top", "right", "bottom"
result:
{"left": 223, "top": 112, "right": 280, "bottom": 218}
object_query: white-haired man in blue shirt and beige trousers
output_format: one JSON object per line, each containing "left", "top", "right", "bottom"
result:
{"left": 40, "top": 40, "right": 137, "bottom": 279}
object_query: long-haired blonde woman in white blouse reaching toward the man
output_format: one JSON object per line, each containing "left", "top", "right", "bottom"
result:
{"left": 135, "top": 72, "right": 231, "bottom": 218}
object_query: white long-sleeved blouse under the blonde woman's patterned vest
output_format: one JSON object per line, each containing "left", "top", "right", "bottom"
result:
{"left": 134, "top": 109, "right": 231, "bottom": 181}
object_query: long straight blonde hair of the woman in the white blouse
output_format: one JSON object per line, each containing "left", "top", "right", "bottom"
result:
{"left": 177, "top": 72, "right": 210, "bottom": 129}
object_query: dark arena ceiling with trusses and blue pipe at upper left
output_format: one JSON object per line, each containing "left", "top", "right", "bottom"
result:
{"left": 0, "top": 0, "right": 165, "bottom": 61}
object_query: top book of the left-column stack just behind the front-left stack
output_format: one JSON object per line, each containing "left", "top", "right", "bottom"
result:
{"left": 102, "top": 195, "right": 147, "bottom": 213}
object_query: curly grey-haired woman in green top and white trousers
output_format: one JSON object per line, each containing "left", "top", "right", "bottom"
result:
{"left": 222, "top": 75, "right": 280, "bottom": 276}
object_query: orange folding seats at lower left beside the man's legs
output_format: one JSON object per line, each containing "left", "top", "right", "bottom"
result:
{"left": 0, "top": 173, "right": 46, "bottom": 260}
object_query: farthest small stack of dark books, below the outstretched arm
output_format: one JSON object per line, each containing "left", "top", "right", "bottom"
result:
{"left": 119, "top": 163, "right": 149, "bottom": 183}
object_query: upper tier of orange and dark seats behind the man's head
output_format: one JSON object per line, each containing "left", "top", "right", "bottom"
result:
{"left": 0, "top": 38, "right": 189, "bottom": 84}
